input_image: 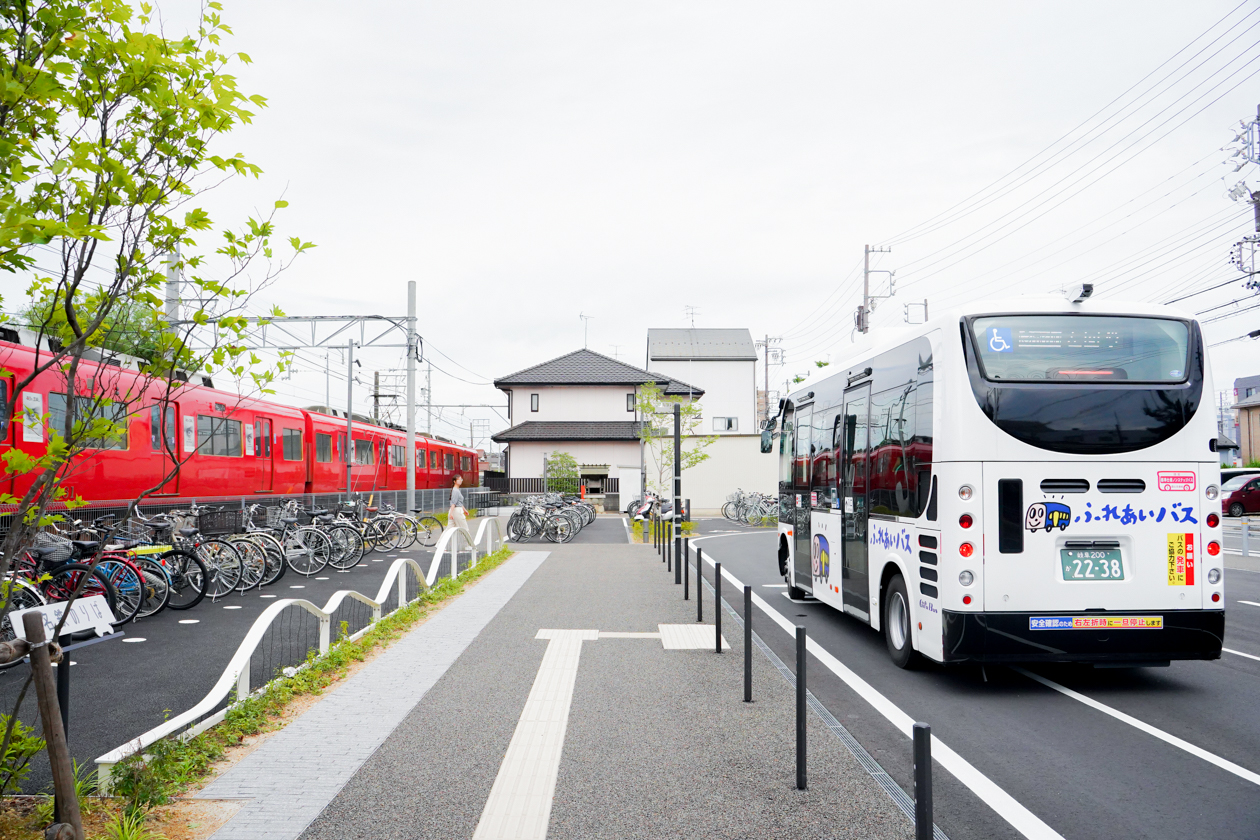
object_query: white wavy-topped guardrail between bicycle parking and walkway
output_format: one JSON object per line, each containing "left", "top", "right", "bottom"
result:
{"left": 96, "top": 516, "right": 503, "bottom": 793}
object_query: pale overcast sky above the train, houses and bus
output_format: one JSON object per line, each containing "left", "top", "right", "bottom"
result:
{"left": 12, "top": 0, "right": 1260, "bottom": 445}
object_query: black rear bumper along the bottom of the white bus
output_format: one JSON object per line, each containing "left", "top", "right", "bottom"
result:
{"left": 941, "top": 610, "right": 1225, "bottom": 662}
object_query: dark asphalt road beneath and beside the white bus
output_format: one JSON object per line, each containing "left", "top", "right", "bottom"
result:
{"left": 699, "top": 520, "right": 1260, "bottom": 840}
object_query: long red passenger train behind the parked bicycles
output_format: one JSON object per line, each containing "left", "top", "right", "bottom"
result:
{"left": 0, "top": 340, "right": 480, "bottom": 501}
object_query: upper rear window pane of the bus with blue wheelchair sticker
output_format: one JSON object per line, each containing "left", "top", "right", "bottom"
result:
{"left": 971, "top": 315, "right": 1189, "bottom": 383}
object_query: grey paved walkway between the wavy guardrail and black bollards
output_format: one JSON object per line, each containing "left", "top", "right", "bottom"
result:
{"left": 198, "top": 536, "right": 914, "bottom": 840}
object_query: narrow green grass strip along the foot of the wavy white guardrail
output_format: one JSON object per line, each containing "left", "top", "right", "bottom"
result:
{"left": 112, "top": 547, "right": 513, "bottom": 811}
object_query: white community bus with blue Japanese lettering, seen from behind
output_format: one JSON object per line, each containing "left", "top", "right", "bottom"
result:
{"left": 762, "top": 297, "right": 1225, "bottom": 667}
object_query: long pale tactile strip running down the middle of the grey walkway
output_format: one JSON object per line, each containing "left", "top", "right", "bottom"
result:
{"left": 473, "top": 630, "right": 600, "bottom": 840}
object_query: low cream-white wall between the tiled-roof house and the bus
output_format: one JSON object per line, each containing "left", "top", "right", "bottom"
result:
{"left": 645, "top": 434, "right": 779, "bottom": 516}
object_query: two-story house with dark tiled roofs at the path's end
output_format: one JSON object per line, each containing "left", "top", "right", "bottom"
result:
{"left": 491, "top": 349, "right": 704, "bottom": 501}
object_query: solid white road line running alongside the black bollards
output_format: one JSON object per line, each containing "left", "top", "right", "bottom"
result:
{"left": 692, "top": 538, "right": 1062, "bottom": 840}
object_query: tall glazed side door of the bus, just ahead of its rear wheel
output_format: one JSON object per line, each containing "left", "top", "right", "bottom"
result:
{"left": 837, "top": 384, "right": 871, "bottom": 615}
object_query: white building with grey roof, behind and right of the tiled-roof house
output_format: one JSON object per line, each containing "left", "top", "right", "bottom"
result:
{"left": 646, "top": 329, "right": 777, "bottom": 514}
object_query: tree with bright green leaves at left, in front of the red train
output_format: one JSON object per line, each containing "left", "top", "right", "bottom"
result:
{"left": 0, "top": 0, "right": 311, "bottom": 826}
